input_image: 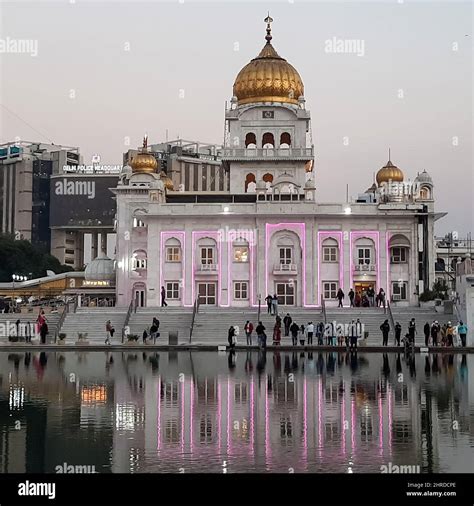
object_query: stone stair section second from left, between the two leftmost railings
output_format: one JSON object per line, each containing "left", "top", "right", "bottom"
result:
{"left": 61, "top": 307, "right": 127, "bottom": 345}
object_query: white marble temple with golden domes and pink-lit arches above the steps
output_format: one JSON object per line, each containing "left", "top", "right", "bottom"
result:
{"left": 113, "top": 18, "right": 443, "bottom": 307}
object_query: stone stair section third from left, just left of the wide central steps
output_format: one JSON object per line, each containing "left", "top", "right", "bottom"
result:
{"left": 128, "top": 307, "right": 193, "bottom": 344}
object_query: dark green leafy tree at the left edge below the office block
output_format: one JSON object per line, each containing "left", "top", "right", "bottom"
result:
{"left": 0, "top": 234, "right": 74, "bottom": 282}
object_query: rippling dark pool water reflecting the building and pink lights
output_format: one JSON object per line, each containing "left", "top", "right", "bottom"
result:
{"left": 0, "top": 351, "right": 474, "bottom": 473}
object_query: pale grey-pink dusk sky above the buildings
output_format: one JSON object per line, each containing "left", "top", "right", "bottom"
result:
{"left": 0, "top": 0, "right": 474, "bottom": 236}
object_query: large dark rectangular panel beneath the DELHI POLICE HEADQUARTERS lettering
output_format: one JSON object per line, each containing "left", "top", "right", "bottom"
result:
{"left": 50, "top": 175, "right": 118, "bottom": 227}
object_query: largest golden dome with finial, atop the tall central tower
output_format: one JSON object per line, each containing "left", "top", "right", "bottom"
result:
{"left": 234, "top": 17, "right": 304, "bottom": 105}
